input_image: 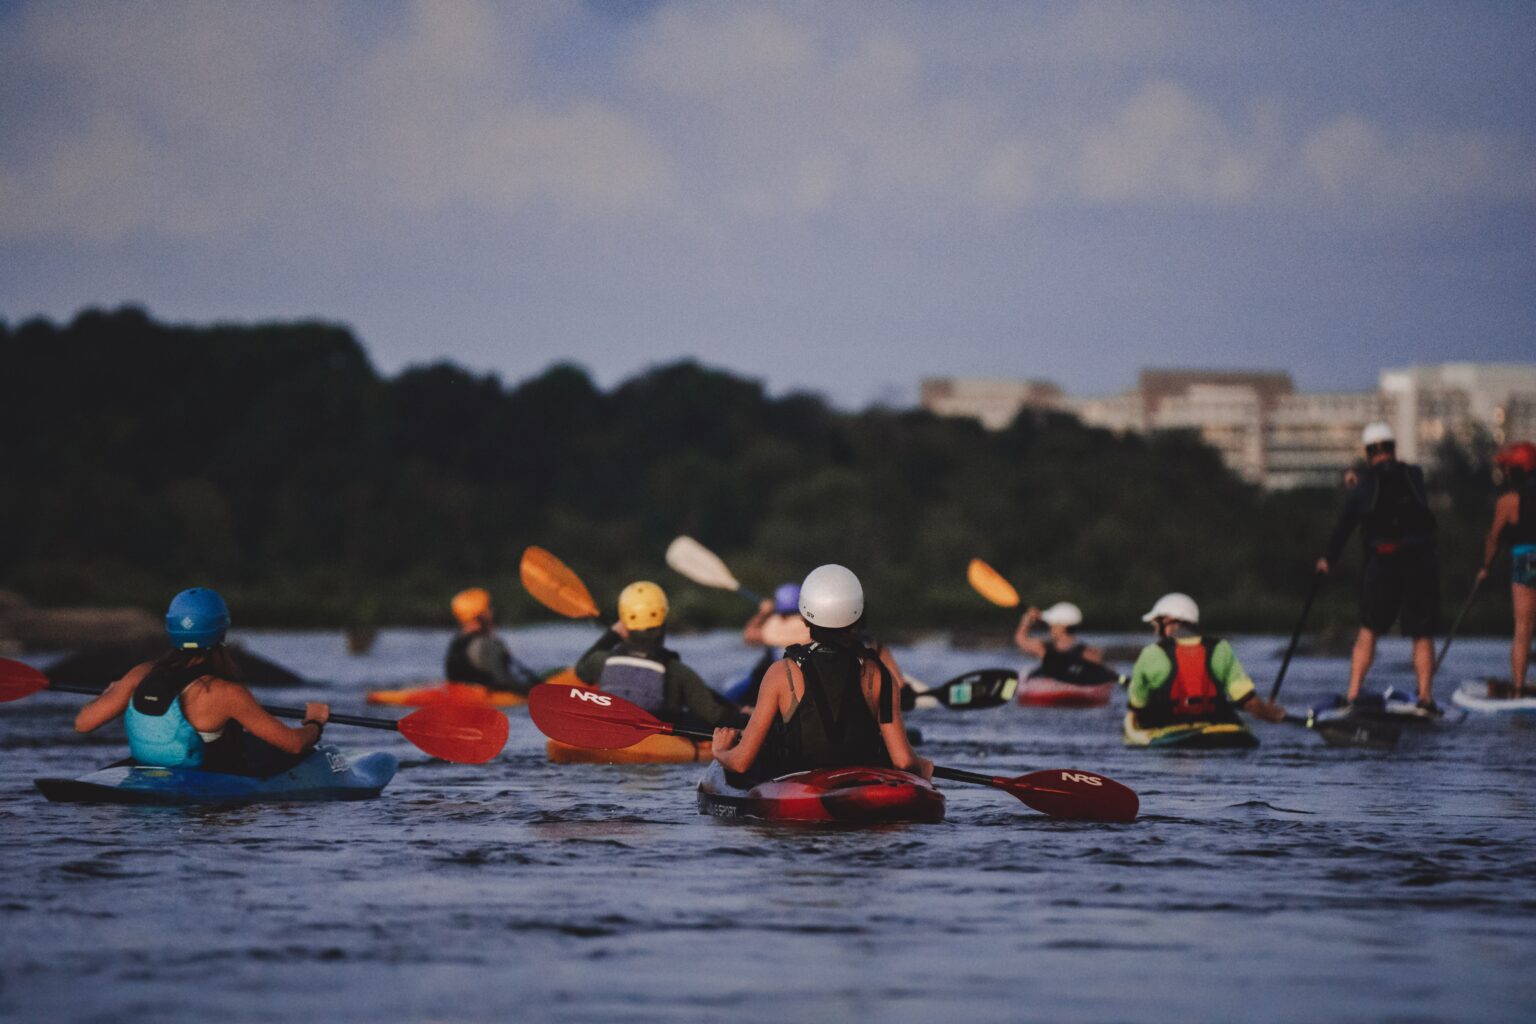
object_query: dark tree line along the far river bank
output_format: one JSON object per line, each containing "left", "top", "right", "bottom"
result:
{"left": 0, "top": 307, "right": 1507, "bottom": 634}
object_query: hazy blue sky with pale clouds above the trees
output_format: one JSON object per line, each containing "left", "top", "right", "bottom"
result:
{"left": 0, "top": 0, "right": 1536, "bottom": 407}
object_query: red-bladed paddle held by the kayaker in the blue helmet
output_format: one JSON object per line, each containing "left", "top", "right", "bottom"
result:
{"left": 0, "top": 659, "right": 510, "bottom": 765}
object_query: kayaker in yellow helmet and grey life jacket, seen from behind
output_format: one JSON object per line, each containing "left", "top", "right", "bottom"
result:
{"left": 576, "top": 580, "right": 742, "bottom": 728}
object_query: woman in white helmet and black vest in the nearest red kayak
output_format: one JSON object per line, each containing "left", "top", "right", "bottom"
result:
{"left": 714, "top": 565, "right": 934, "bottom": 778}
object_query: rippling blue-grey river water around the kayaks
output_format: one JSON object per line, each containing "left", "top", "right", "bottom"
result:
{"left": 0, "top": 625, "right": 1536, "bottom": 1024}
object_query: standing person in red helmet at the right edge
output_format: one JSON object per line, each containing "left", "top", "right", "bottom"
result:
{"left": 1478, "top": 441, "right": 1536, "bottom": 697}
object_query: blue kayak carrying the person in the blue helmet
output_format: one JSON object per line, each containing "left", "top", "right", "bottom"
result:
{"left": 35, "top": 746, "right": 399, "bottom": 806}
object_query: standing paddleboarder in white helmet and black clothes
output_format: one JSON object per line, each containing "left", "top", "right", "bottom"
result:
{"left": 1316, "top": 422, "right": 1439, "bottom": 714}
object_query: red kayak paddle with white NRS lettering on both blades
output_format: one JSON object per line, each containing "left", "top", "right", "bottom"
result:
{"left": 528, "top": 685, "right": 1140, "bottom": 821}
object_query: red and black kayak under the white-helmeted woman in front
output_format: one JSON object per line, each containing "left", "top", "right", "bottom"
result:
{"left": 699, "top": 761, "right": 945, "bottom": 824}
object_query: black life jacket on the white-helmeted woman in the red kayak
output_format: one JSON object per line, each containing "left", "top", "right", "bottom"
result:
{"left": 770, "top": 643, "right": 895, "bottom": 775}
